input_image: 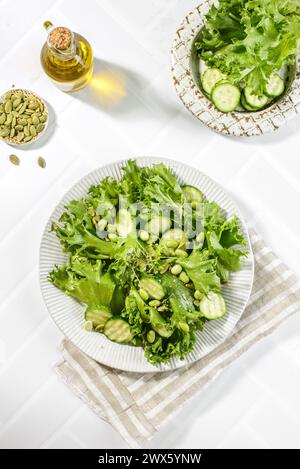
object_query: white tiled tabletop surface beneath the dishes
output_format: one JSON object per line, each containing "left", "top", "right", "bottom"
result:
{"left": 0, "top": 0, "right": 300, "bottom": 448}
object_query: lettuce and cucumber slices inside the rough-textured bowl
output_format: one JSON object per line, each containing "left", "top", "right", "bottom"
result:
{"left": 195, "top": 0, "right": 300, "bottom": 112}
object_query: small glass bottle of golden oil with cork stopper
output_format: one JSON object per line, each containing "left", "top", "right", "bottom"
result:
{"left": 41, "top": 21, "right": 93, "bottom": 93}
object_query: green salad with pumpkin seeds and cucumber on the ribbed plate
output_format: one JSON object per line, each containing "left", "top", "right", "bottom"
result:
{"left": 49, "top": 160, "right": 247, "bottom": 365}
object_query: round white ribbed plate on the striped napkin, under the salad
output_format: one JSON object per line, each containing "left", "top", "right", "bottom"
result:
{"left": 40, "top": 158, "right": 254, "bottom": 373}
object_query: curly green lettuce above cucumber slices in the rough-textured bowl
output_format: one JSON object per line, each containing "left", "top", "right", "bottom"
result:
{"left": 195, "top": 0, "right": 300, "bottom": 95}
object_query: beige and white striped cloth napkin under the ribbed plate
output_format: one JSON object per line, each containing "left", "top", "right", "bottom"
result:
{"left": 56, "top": 231, "right": 300, "bottom": 448}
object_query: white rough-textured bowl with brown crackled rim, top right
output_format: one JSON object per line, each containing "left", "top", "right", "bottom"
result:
{"left": 171, "top": 0, "right": 300, "bottom": 137}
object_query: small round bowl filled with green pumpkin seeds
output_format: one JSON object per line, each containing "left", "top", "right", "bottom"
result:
{"left": 0, "top": 89, "right": 49, "bottom": 145}
